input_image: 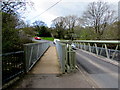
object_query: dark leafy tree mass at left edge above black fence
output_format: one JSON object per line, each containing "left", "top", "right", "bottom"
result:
{"left": 0, "top": 0, "right": 31, "bottom": 53}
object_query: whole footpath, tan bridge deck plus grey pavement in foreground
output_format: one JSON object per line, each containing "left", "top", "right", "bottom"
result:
{"left": 11, "top": 46, "right": 97, "bottom": 90}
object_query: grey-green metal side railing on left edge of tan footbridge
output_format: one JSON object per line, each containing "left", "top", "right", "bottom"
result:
{"left": 24, "top": 42, "right": 50, "bottom": 72}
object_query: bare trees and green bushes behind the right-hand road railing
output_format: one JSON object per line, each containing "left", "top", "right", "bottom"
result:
{"left": 51, "top": 1, "right": 120, "bottom": 40}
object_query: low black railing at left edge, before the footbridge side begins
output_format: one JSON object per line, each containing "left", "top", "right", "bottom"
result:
{"left": 1, "top": 51, "right": 24, "bottom": 85}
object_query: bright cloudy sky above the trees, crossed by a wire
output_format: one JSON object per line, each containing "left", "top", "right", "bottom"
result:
{"left": 23, "top": 0, "right": 119, "bottom": 27}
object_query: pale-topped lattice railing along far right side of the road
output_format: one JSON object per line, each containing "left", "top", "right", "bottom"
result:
{"left": 73, "top": 40, "right": 120, "bottom": 61}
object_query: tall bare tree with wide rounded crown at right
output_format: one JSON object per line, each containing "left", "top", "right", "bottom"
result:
{"left": 83, "top": 1, "right": 116, "bottom": 39}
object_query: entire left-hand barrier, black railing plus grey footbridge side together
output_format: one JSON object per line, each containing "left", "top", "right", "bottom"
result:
{"left": 0, "top": 42, "right": 49, "bottom": 85}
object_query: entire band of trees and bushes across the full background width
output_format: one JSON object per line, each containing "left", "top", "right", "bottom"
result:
{"left": 0, "top": 1, "right": 120, "bottom": 53}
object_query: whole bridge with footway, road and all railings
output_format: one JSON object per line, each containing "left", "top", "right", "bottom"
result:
{"left": 1, "top": 40, "right": 120, "bottom": 88}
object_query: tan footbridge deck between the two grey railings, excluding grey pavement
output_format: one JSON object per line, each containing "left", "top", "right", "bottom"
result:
{"left": 30, "top": 46, "right": 61, "bottom": 74}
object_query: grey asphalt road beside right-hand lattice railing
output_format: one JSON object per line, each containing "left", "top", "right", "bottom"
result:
{"left": 76, "top": 50, "right": 118, "bottom": 88}
